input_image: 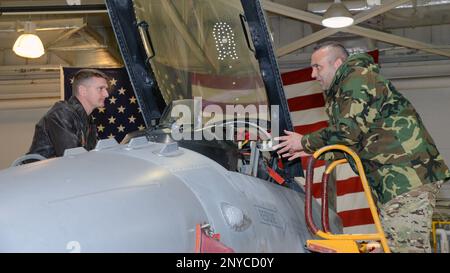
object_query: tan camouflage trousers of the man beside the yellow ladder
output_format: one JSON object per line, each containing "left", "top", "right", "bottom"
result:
{"left": 380, "top": 181, "right": 442, "bottom": 253}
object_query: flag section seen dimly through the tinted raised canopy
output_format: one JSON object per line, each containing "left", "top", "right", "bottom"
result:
{"left": 152, "top": 63, "right": 269, "bottom": 130}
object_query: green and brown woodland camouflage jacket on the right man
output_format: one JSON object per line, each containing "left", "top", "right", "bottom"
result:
{"left": 302, "top": 54, "right": 450, "bottom": 204}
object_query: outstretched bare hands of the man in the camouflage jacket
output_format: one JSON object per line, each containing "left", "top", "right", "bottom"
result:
{"left": 273, "top": 130, "right": 308, "bottom": 161}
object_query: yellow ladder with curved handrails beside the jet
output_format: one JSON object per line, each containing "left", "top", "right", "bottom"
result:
{"left": 305, "top": 145, "right": 391, "bottom": 253}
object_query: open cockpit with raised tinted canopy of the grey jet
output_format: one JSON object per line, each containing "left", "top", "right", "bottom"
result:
{"left": 109, "top": 0, "right": 301, "bottom": 183}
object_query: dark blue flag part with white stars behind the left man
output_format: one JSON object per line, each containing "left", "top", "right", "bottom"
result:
{"left": 62, "top": 67, "right": 145, "bottom": 143}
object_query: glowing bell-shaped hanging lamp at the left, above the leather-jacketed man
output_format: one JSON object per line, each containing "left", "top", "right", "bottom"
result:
{"left": 13, "top": 22, "right": 45, "bottom": 58}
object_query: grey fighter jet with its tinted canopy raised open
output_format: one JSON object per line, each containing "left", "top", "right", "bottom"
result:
{"left": 0, "top": 0, "right": 342, "bottom": 253}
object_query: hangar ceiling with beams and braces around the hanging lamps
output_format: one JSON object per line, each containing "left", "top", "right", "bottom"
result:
{"left": 0, "top": 0, "right": 450, "bottom": 80}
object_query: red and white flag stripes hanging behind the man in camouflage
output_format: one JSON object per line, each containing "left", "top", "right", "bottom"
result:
{"left": 282, "top": 51, "right": 378, "bottom": 233}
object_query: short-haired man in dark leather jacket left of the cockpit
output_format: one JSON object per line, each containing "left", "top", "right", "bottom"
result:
{"left": 28, "top": 69, "right": 109, "bottom": 158}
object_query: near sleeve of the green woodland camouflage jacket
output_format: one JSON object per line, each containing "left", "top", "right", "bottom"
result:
{"left": 302, "top": 68, "right": 386, "bottom": 153}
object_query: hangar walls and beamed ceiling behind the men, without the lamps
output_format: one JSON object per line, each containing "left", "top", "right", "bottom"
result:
{"left": 0, "top": 0, "right": 450, "bottom": 251}
